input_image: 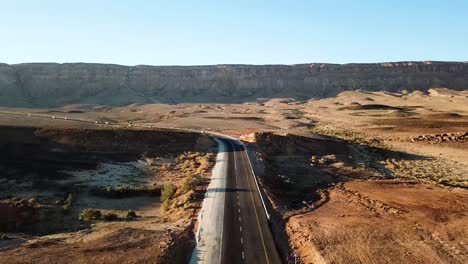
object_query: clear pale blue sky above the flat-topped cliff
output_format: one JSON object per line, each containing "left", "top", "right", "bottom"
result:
{"left": 0, "top": 0, "right": 468, "bottom": 65}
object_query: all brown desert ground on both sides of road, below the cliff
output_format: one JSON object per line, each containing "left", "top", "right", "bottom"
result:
{"left": 0, "top": 88, "right": 468, "bottom": 263}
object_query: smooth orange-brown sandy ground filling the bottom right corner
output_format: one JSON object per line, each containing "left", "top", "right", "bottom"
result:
{"left": 287, "top": 181, "right": 468, "bottom": 263}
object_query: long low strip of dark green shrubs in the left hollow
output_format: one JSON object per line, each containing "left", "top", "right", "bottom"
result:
{"left": 91, "top": 185, "right": 162, "bottom": 198}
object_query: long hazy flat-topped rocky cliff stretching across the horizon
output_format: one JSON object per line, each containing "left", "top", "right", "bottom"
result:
{"left": 0, "top": 62, "right": 468, "bottom": 107}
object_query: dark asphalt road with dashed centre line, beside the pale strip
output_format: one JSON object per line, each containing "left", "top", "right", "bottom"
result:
{"left": 221, "top": 139, "right": 281, "bottom": 264}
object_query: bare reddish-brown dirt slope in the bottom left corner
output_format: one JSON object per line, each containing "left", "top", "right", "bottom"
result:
{"left": 0, "top": 199, "right": 193, "bottom": 263}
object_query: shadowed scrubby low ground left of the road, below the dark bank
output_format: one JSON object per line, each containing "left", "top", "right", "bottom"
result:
{"left": 0, "top": 127, "right": 216, "bottom": 263}
